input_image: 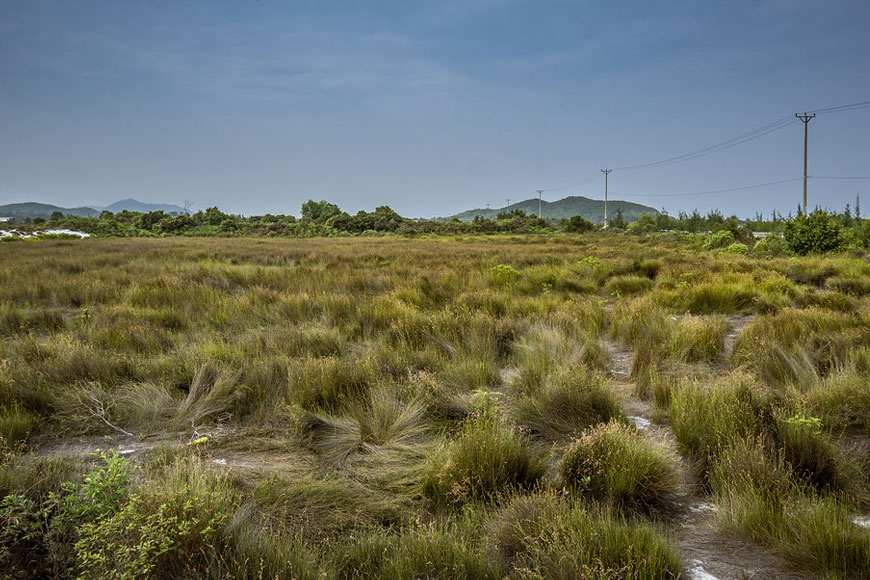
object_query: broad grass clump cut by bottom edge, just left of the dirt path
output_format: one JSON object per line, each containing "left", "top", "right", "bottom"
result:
{"left": 488, "top": 492, "right": 682, "bottom": 580}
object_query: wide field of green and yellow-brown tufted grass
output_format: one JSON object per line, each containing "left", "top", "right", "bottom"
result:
{"left": 0, "top": 232, "right": 870, "bottom": 580}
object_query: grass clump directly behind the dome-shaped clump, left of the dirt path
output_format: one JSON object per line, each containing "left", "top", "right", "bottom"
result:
{"left": 511, "top": 365, "right": 622, "bottom": 439}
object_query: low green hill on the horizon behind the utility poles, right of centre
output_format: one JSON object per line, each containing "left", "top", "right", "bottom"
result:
{"left": 447, "top": 195, "right": 659, "bottom": 223}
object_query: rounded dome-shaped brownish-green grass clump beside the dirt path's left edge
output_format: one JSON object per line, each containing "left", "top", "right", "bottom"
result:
{"left": 560, "top": 422, "right": 677, "bottom": 510}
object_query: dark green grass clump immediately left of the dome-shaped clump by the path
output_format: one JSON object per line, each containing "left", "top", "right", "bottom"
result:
{"left": 423, "top": 412, "right": 547, "bottom": 505}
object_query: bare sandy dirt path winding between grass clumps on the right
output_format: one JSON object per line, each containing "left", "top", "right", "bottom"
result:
{"left": 605, "top": 316, "right": 810, "bottom": 580}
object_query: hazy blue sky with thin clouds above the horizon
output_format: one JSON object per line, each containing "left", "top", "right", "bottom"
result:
{"left": 0, "top": 0, "right": 870, "bottom": 217}
